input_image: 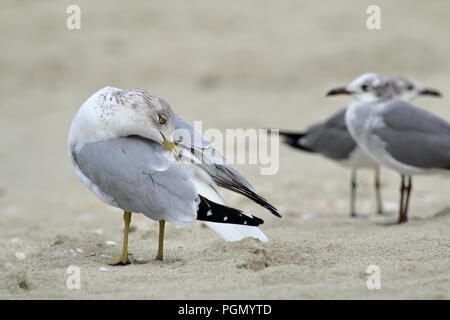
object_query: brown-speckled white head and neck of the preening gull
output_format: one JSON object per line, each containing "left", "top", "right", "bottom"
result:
{"left": 69, "top": 87, "right": 176, "bottom": 151}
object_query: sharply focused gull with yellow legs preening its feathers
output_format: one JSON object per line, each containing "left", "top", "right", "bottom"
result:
{"left": 68, "top": 87, "right": 279, "bottom": 264}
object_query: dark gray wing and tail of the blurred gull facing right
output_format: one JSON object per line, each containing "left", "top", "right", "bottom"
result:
{"left": 280, "top": 108, "right": 357, "bottom": 160}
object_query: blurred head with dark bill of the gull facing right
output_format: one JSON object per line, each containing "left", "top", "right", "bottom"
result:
{"left": 388, "top": 75, "right": 442, "bottom": 101}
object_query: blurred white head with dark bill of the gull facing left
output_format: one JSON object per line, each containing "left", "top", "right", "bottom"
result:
{"left": 327, "top": 73, "right": 395, "bottom": 102}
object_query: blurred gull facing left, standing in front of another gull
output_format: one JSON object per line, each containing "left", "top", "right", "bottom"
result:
{"left": 328, "top": 73, "right": 450, "bottom": 223}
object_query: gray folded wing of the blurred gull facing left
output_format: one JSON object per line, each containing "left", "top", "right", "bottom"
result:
{"left": 373, "top": 100, "right": 450, "bottom": 169}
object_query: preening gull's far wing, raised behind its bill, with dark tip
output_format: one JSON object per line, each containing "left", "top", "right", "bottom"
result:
{"left": 174, "top": 115, "right": 281, "bottom": 217}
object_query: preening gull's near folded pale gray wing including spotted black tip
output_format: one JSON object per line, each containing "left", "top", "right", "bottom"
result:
{"left": 74, "top": 136, "right": 262, "bottom": 226}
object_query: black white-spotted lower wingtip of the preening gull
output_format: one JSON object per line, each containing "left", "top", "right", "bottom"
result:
{"left": 197, "top": 195, "right": 264, "bottom": 227}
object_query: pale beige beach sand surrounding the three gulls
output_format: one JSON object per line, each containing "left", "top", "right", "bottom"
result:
{"left": 0, "top": 0, "right": 450, "bottom": 299}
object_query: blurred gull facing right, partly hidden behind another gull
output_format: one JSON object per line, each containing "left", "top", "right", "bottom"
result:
{"left": 279, "top": 75, "right": 441, "bottom": 217}
